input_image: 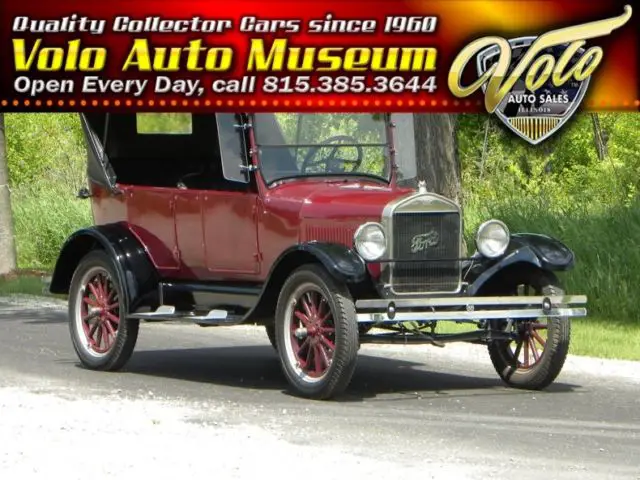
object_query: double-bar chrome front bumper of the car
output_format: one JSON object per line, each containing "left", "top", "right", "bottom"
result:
{"left": 356, "top": 295, "right": 587, "bottom": 323}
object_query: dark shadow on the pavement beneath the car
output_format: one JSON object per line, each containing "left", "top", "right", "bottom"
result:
{"left": 125, "top": 345, "right": 576, "bottom": 402}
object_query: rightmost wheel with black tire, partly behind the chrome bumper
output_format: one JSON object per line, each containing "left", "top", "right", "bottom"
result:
{"left": 489, "top": 270, "right": 571, "bottom": 390}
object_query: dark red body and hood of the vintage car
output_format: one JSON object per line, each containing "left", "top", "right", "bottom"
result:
{"left": 97, "top": 177, "right": 411, "bottom": 281}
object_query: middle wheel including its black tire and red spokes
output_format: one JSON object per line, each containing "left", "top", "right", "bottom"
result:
{"left": 276, "top": 264, "right": 359, "bottom": 400}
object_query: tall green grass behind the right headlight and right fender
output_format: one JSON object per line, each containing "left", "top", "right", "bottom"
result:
{"left": 465, "top": 193, "right": 640, "bottom": 328}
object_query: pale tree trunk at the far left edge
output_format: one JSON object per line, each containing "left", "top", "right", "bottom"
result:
{"left": 0, "top": 113, "right": 16, "bottom": 275}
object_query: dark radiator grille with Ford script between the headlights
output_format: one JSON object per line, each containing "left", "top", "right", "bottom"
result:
{"left": 391, "top": 212, "right": 460, "bottom": 293}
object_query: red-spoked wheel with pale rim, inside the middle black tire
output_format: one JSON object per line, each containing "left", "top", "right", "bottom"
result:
{"left": 284, "top": 284, "right": 336, "bottom": 383}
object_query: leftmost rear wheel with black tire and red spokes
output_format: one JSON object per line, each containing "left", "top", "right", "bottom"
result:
{"left": 69, "top": 250, "right": 140, "bottom": 371}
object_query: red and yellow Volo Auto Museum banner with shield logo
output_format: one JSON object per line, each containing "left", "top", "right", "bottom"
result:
{"left": 0, "top": 0, "right": 640, "bottom": 138}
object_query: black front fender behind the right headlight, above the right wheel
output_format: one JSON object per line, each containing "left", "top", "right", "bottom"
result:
{"left": 467, "top": 233, "right": 575, "bottom": 295}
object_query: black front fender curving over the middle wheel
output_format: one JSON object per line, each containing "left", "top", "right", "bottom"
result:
{"left": 247, "top": 241, "right": 369, "bottom": 321}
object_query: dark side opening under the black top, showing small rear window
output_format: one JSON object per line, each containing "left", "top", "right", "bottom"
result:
{"left": 84, "top": 112, "right": 248, "bottom": 190}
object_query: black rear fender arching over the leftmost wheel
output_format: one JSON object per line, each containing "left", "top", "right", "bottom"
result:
{"left": 49, "top": 223, "right": 160, "bottom": 311}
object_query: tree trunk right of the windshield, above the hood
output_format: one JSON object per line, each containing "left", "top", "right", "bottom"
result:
{"left": 413, "top": 113, "right": 462, "bottom": 205}
